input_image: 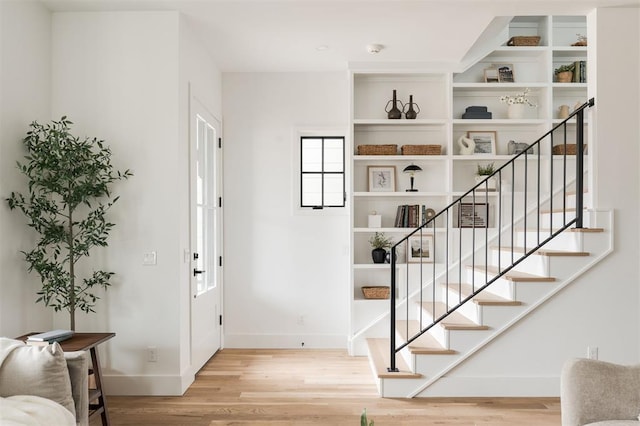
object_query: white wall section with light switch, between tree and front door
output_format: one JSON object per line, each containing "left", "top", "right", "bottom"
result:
{"left": 52, "top": 12, "right": 187, "bottom": 394}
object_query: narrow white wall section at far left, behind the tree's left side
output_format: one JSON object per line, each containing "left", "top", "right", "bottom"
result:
{"left": 0, "top": 0, "right": 52, "bottom": 337}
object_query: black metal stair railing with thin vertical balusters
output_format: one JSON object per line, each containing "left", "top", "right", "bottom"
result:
{"left": 388, "top": 98, "right": 595, "bottom": 372}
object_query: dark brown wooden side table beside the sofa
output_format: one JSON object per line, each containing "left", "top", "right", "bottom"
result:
{"left": 16, "top": 332, "right": 116, "bottom": 426}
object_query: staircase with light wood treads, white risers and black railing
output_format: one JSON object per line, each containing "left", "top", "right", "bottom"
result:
{"left": 363, "top": 100, "right": 613, "bottom": 397}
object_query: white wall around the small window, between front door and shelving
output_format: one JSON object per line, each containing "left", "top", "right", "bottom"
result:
{"left": 223, "top": 72, "right": 350, "bottom": 348}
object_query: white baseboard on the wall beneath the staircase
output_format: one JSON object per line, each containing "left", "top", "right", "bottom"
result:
{"left": 416, "top": 377, "right": 560, "bottom": 398}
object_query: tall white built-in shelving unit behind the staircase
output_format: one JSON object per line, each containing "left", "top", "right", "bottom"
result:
{"left": 351, "top": 16, "right": 588, "bottom": 352}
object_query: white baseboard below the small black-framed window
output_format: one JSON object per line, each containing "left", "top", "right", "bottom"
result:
{"left": 224, "top": 334, "right": 348, "bottom": 349}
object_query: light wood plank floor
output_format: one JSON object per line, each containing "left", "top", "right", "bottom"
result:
{"left": 91, "top": 349, "right": 560, "bottom": 426}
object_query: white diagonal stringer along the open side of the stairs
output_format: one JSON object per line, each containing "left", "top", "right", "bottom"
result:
{"left": 380, "top": 210, "right": 614, "bottom": 398}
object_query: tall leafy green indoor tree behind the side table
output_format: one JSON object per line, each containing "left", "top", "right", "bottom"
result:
{"left": 7, "top": 116, "right": 132, "bottom": 330}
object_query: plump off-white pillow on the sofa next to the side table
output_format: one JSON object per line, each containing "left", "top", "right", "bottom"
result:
{"left": 0, "top": 338, "right": 76, "bottom": 416}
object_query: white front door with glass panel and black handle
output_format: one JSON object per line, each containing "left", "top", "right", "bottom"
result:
{"left": 190, "top": 97, "right": 222, "bottom": 373}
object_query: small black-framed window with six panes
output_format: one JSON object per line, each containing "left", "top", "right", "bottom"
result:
{"left": 300, "top": 136, "right": 346, "bottom": 209}
